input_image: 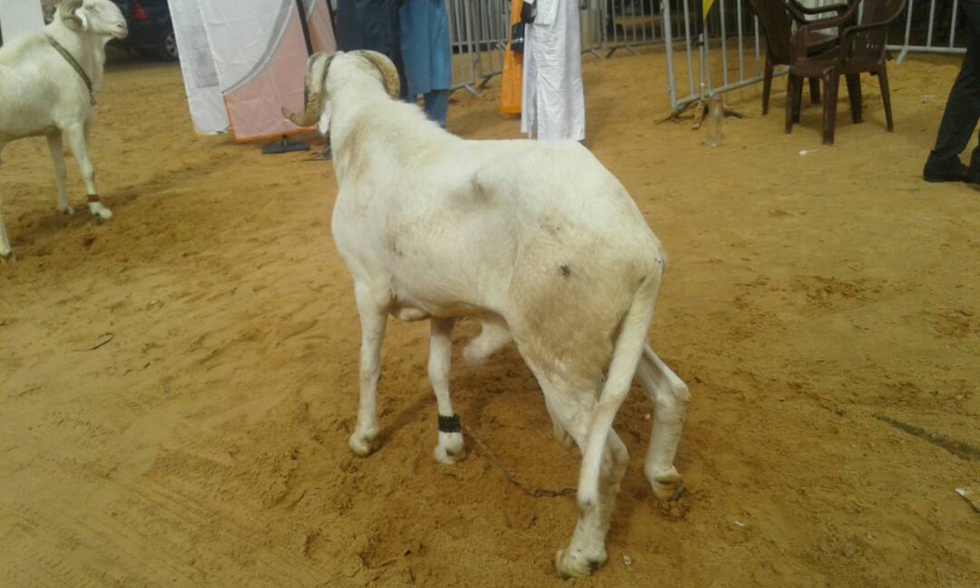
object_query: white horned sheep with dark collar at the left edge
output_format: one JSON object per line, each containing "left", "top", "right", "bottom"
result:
{"left": 0, "top": 0, "right": 128, "bottom": 257}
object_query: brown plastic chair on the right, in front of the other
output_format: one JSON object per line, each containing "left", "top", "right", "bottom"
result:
{"left": 786, "top": 0, "right": 905, "bottom": 145}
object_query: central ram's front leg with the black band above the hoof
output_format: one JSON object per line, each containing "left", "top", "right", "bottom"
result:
{"left": 429, "top": 319, "right": 466, "bottom": 465}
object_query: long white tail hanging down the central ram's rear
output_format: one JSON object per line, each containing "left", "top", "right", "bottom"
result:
{"left": 578, "top": 266, "right": 662, "bottom": 509}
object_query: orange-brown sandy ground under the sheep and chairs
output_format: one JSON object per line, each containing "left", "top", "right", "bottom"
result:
{"left": 0, "top": 47, "right": 980, "bottom": 587}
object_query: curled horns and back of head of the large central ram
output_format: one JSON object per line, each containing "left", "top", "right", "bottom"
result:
{"left": 282, "top": 51, "right": 401, "bottom": 135}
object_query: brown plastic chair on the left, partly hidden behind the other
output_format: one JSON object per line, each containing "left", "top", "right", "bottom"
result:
{"left": 749, "top": 0, "right": 849, "bottom": 115}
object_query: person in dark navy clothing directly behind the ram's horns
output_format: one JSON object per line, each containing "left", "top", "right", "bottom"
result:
{"left": 337, "top": 0, "right": 408, "bottom": 98}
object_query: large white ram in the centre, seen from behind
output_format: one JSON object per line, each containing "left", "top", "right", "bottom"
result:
{"left": 284, "top": 51, "right": 689, "bottom": 576}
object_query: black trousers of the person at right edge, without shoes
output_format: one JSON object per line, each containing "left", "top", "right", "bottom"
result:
{"left": 930, "top": 0, "right": 980, "bottom": 160}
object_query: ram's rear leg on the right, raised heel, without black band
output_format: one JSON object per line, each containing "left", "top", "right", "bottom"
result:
{"left": 636, "top": 345, "right": 691, "bottom": 500}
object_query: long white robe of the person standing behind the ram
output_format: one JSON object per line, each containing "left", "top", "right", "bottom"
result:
{"left": 521, "top": 0, "right": 585, "bottom": 141}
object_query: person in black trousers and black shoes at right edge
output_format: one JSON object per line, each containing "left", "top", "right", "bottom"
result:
{"left": 922, "top": 0, "right": 980, "bottom": 184}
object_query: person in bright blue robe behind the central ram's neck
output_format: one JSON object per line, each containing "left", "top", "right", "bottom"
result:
{"left": 400, "top": 0, "right": 453, "bottom": 127}
